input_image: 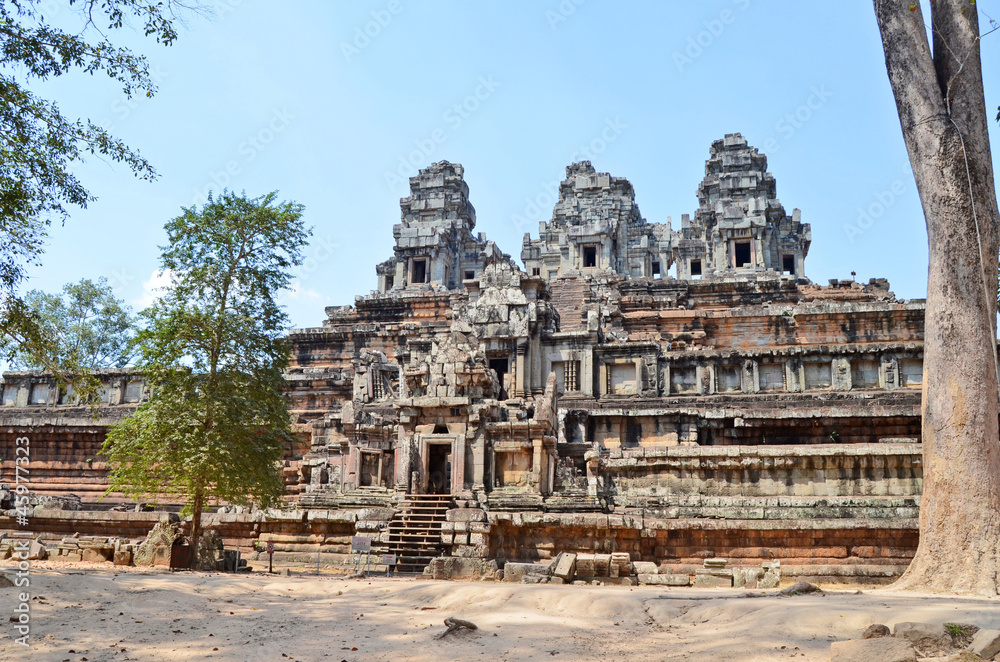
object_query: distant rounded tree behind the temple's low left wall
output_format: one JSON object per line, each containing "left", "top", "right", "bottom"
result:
{"left": 0, "top": 278, "right": 136, "bottom": 371}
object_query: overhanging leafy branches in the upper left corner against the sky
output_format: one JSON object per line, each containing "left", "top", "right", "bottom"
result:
{"left": 0, "top": 0, "right": 193, "bottom": 374}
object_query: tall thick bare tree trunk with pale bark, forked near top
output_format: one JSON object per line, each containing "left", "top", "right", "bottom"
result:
{"left": 875, "top": 0, "right": 1000, "bottom": 596}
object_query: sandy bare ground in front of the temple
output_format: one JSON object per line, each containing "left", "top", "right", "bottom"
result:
{"left": 0, "top": 562, "right": 1000, "bottom": 662}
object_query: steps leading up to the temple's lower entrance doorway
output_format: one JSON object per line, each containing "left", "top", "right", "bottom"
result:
{"left": 384, "top": 494, "right": 452, "bottom": 572}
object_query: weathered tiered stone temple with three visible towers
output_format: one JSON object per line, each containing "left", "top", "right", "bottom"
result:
{"left": 0, "top": 134, "right": 924, "bottom": 581}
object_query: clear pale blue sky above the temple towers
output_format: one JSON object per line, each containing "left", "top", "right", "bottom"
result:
{"left": 19, "top": 0, "right": 1000, "bottom": 327}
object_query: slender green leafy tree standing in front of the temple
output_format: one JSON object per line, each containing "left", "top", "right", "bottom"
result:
{"left": 103, "top": 192, "right": 310, "bottom": 556}
